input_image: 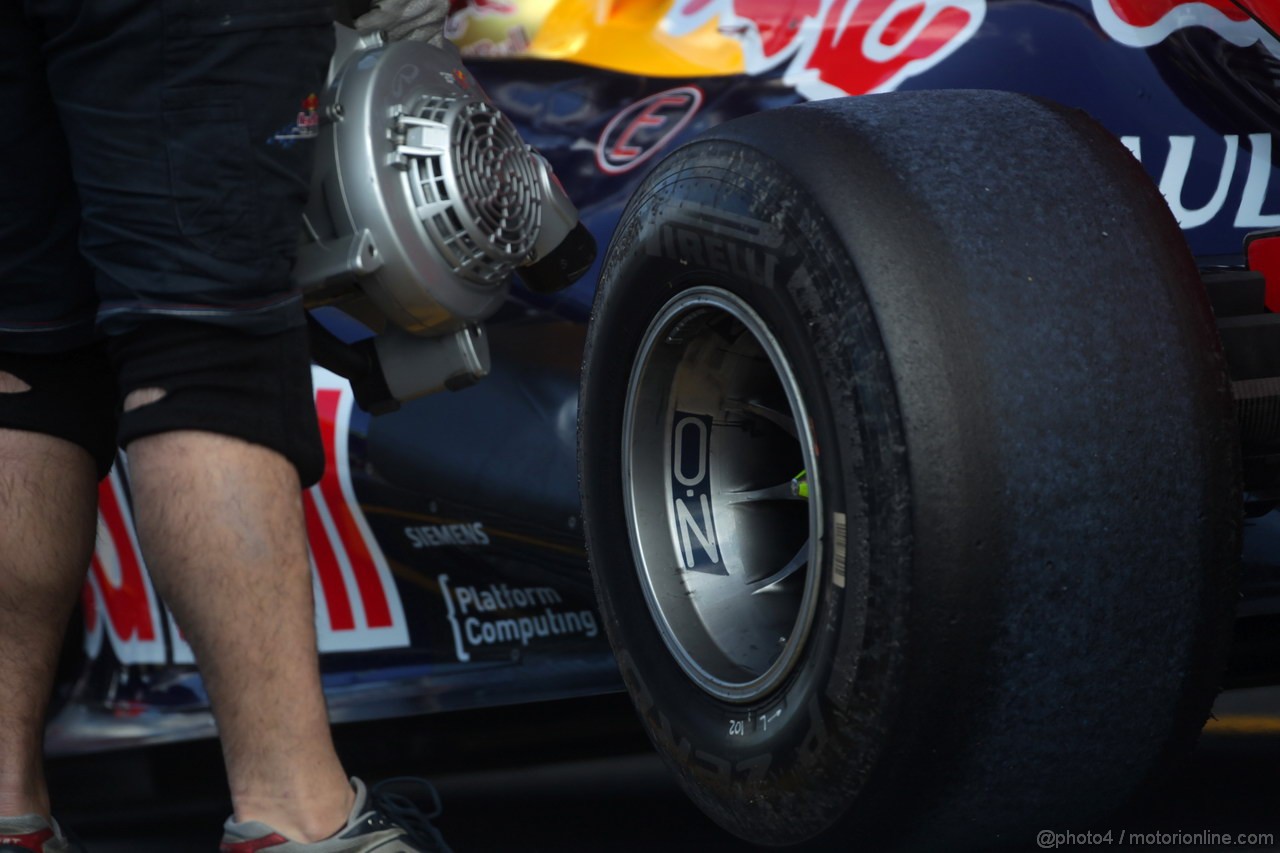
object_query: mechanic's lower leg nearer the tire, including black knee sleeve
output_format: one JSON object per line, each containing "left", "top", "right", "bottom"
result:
{"left": 110, "top": 319, "right": 353, "bottom": 840}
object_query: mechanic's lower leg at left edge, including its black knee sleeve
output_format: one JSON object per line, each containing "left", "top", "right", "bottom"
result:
{"left": 0, "top": 339, "right": 115, "bottom": 817}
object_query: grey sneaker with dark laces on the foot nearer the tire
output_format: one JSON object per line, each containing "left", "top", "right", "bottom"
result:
{"left": 222, "top": 777, "right": 451, "bottom": 853}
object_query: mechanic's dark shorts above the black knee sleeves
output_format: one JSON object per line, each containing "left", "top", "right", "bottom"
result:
{"left": 0, "top": 0, "right": 334, "bottom": 481}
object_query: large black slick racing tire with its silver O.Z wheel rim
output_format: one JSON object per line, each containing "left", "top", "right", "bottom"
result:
{"left": 579, "top": 91, "right": 1240, "bottom": 850}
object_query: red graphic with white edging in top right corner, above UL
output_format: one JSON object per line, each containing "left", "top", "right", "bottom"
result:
{"left": 1093, "top": 0, "right": 1280, "bottom": 56}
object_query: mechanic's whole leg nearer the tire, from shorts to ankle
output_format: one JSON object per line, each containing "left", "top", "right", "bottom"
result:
{"left": 35, "top": 0, "right": 352, "bottom": 839}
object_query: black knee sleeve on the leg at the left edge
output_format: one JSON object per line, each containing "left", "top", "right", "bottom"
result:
{"left": 0, "top": 343, "right": 115, "bottom": 479}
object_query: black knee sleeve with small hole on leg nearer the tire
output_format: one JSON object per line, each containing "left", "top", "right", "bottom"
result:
{"left": 109, "top": 319, "right": 324, "bottom": 487}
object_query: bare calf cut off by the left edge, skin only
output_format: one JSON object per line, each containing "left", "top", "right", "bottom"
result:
{"left": 0, "top": 373, "right": 97, "bottom": 816}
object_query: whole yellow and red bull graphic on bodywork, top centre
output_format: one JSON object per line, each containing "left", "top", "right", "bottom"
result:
{"left": 448, "top": 0, "right": 987, "bottom": 90}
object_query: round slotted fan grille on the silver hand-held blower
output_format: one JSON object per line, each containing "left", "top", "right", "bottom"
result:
{"left": 410, "top": 97, "right": 541, "bottom": 284}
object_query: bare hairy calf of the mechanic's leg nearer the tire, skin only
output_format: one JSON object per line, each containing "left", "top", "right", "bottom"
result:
{"left": 127, "top": 427, "right": 353, "bottom": 840}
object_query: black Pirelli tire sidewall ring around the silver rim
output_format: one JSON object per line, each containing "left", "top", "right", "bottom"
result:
{"left": 582, "top": 142, "right": 910, "bottom": 843}
